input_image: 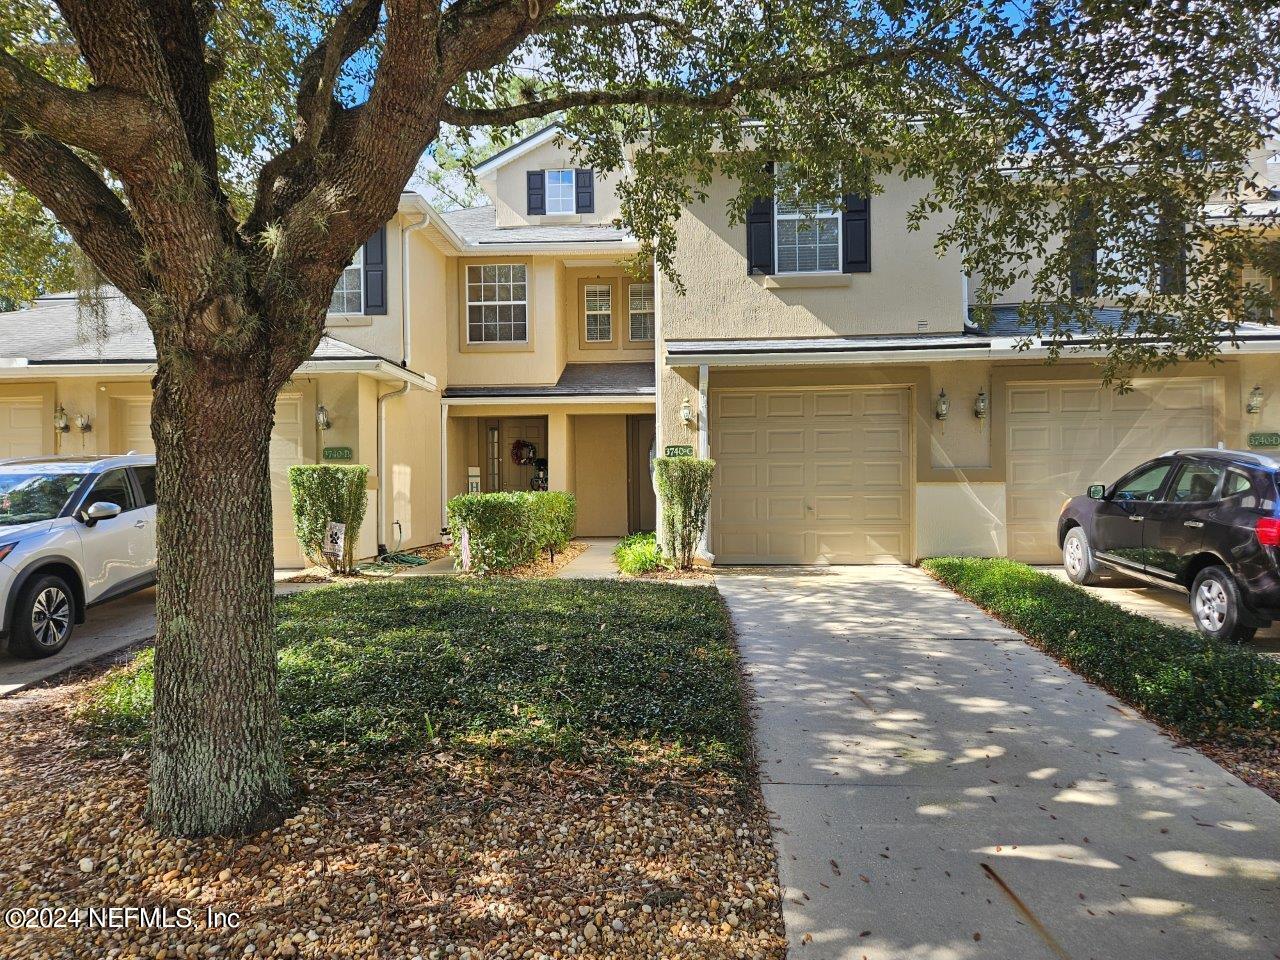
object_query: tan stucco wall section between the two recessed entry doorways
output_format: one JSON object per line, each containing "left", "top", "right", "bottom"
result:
{"left": 572, "top": 415, "right": 627, "bottom": 536}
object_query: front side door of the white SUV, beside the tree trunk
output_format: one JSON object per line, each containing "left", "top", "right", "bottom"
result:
{"left": 79, "top": 468, "right": 155, "bottom": 603}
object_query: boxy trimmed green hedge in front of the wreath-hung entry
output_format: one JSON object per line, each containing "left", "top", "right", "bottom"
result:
{"left": 449, "top": 490, "right": 577, "bottom": 573}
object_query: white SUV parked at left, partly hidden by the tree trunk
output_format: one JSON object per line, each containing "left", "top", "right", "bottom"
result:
{"left": 0, "top": 454, "right": 156, "bottom": 657}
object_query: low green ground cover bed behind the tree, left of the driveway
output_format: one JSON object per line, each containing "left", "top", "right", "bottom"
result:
{"left": 79, "top": 577, "right": 750, "bottom": 774}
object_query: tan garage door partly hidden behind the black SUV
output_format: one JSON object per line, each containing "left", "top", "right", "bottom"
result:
{"left": 1005, "top": 379, "right": 1216, "bottom": 563}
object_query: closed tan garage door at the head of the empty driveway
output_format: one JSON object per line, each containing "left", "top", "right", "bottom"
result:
{"left": 710, "top": 388, "right": 911, "bottom": 563}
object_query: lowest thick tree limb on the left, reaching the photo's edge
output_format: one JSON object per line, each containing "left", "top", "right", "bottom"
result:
{"left": 0, "top": 129, "right": 151, "bottom": 303}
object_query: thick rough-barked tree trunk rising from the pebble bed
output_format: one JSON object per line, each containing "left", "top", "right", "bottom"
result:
{"left": 147, "top": 344, "right": 291, "bottom": 836}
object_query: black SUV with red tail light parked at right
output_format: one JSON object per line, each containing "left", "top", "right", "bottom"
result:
{"left": 1057, "top": 449, "right": 1280, "bottom": 641}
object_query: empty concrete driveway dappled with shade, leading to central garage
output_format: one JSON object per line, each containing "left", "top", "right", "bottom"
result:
{"left": 717, "top": 567, "right": 1280, "bottom": 960}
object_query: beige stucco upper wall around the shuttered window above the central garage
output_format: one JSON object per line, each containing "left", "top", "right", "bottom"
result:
{"left": 660, "top": 172, "right": 965, "bottom": 339}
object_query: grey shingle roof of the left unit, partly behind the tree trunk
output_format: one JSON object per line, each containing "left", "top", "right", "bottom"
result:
{"left": 0, "top": 289, "right": 384, "bottom": 366}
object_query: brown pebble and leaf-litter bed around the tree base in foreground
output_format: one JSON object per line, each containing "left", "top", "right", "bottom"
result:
{"left": 0, "top": 682, "right": 786, "bottom": 960}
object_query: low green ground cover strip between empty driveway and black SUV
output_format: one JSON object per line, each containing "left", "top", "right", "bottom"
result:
{"left": 920, "top": 557, "right": 1280, "bottom": 736}
